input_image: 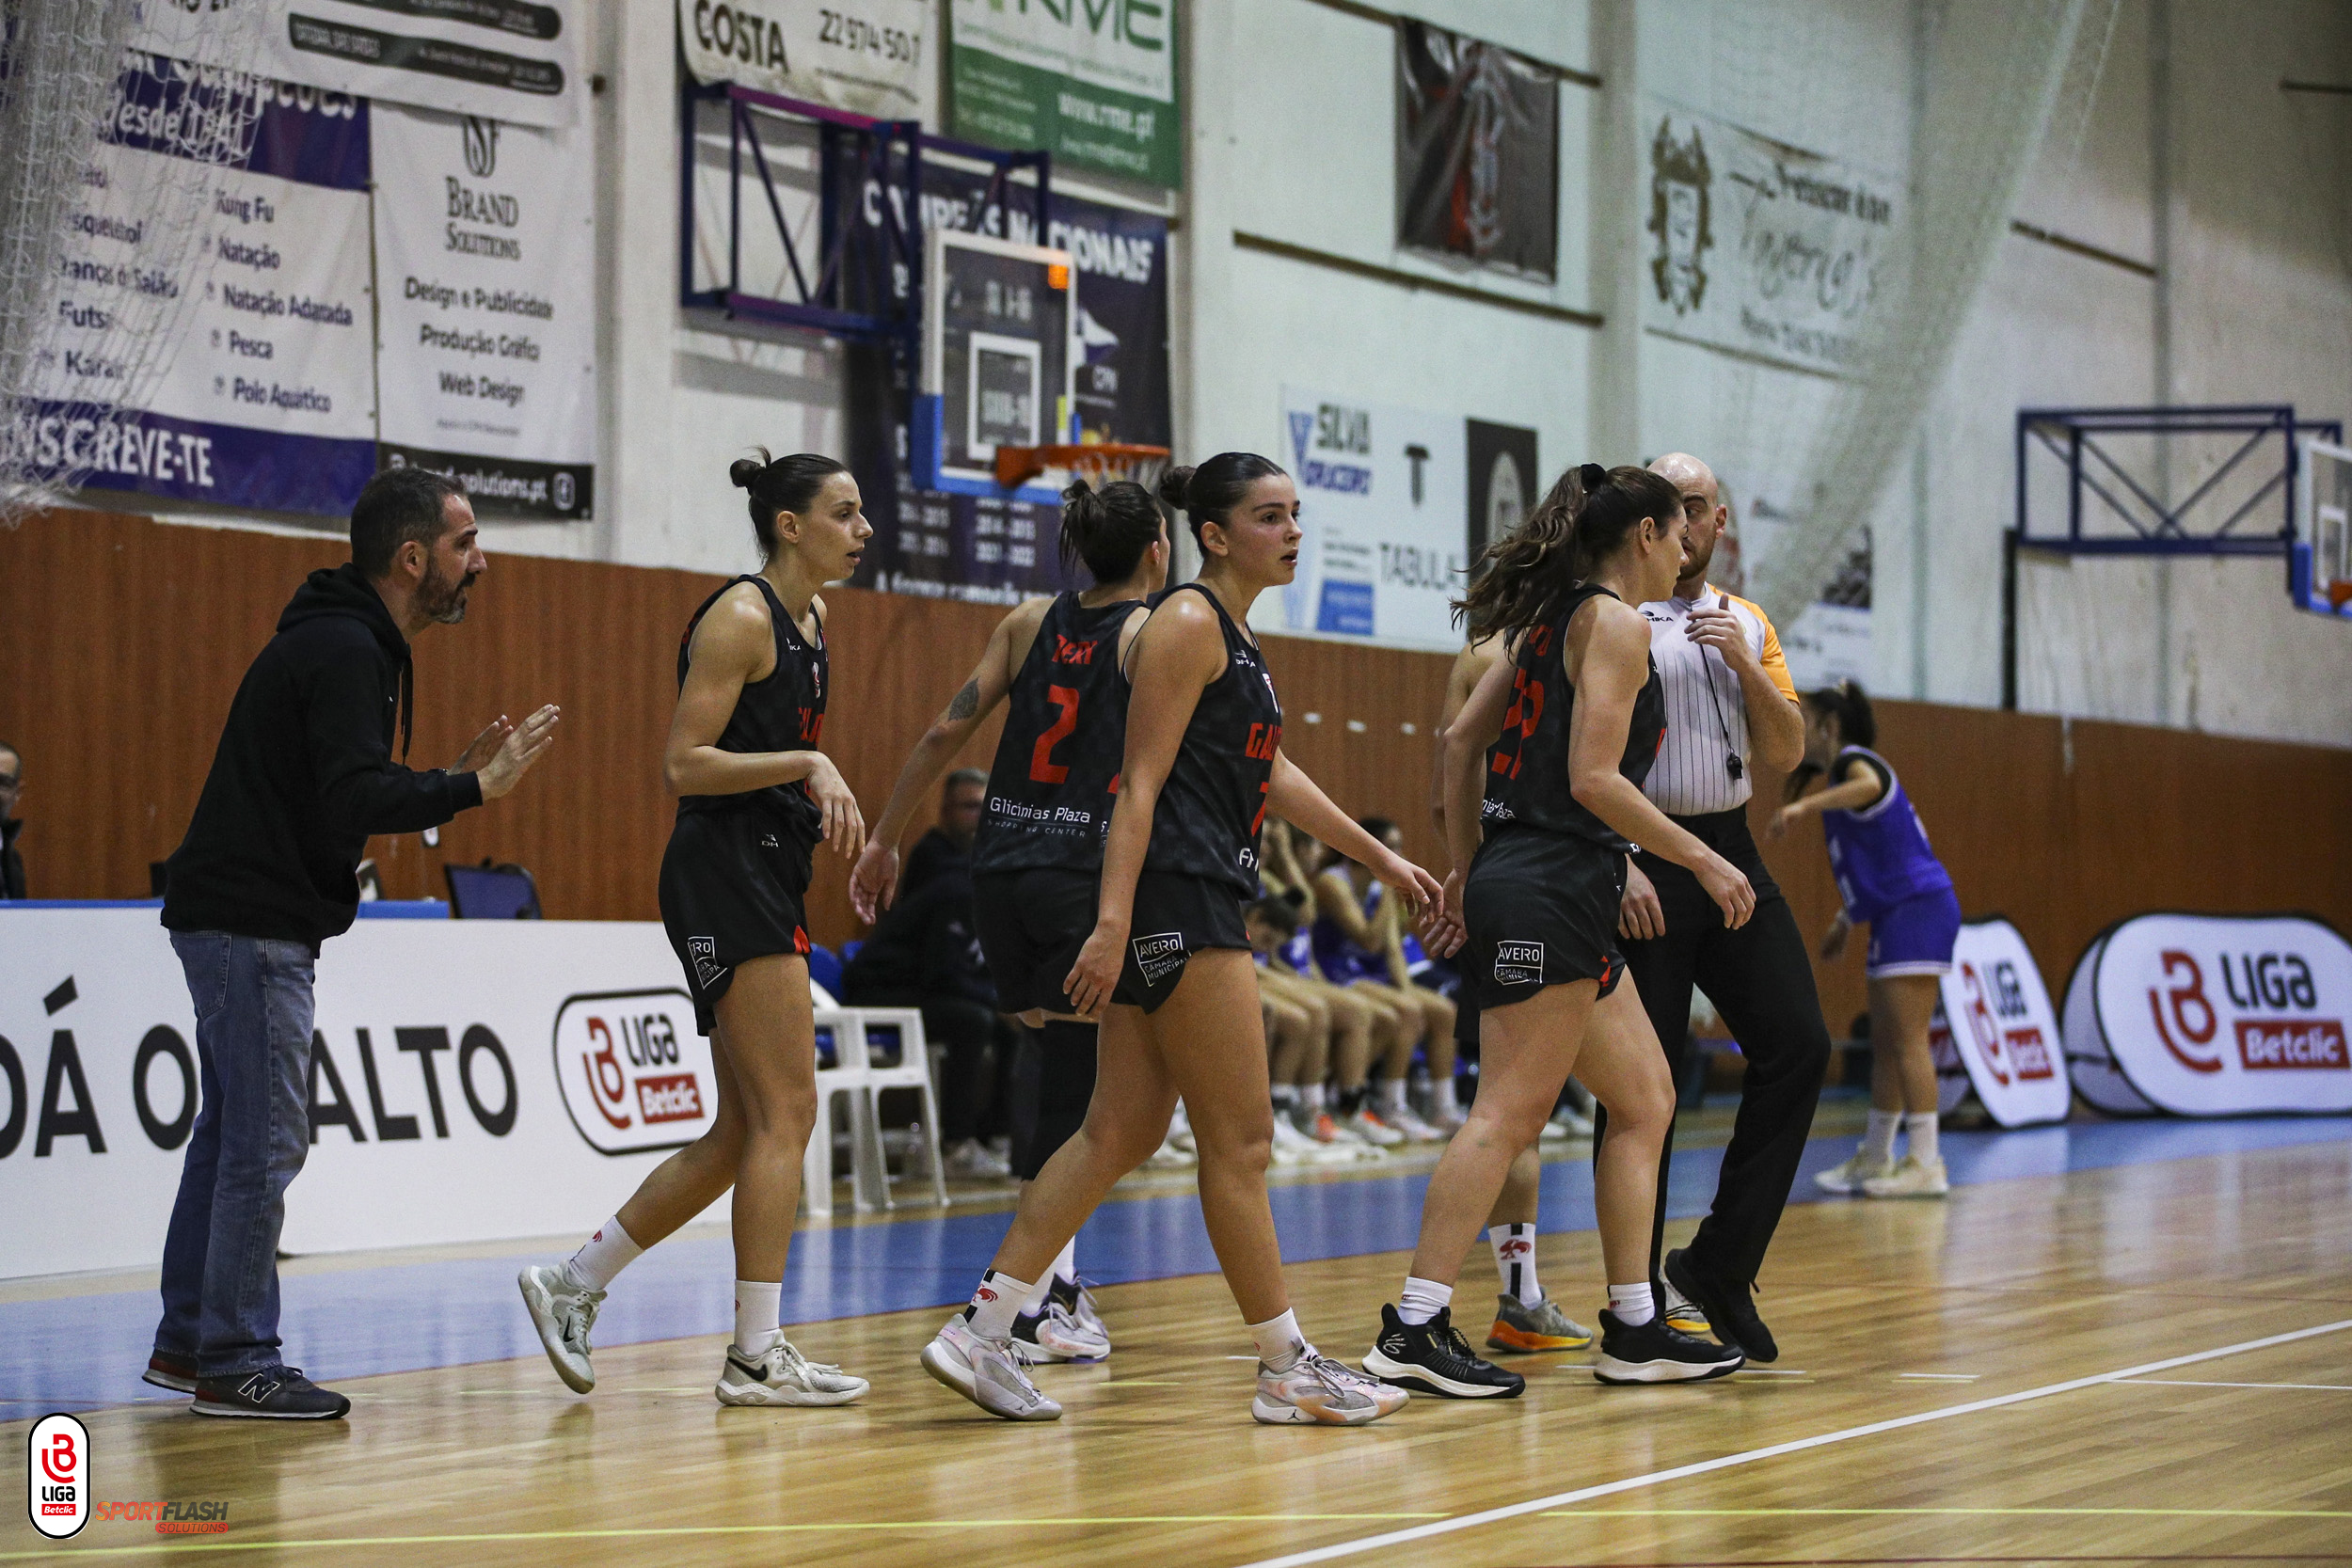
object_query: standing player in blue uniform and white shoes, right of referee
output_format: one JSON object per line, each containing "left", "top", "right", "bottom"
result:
{"left": 1767, "top": 682, "right": 1960, "bottom": 1199}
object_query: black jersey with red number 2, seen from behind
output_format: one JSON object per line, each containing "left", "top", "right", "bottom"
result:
{"left": 972, "top": 593, "right": 1141, "bottom": 872}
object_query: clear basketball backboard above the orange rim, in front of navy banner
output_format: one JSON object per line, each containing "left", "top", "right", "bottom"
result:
{"left": 911, "top": 228, "right": 1080, "bottom": 505}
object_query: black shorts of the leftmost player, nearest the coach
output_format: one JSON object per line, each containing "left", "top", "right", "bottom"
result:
{"left": 661, "top": 811, "right": 814, "bottom": 1035}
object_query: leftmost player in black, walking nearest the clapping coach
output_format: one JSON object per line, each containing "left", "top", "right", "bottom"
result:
{"left": 517, "top": 451, "right": 873, "bottom": 1406}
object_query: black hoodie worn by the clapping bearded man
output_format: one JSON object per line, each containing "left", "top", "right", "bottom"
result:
{"left": 163, "top": 562, "right": 483, "bottom": 947}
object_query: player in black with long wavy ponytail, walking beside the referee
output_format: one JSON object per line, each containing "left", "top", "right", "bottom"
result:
{"left": 1364, "top": 463, "right": 1755, "bottom": 1399}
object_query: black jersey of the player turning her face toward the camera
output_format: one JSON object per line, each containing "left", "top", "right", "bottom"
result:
{"left": 1143, "top": 583, "right": 1282, "bottom": 898}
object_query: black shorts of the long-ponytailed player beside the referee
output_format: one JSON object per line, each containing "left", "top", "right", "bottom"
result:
{"left": 1463, "top": 828, "right": 1626, "bottom": 1011}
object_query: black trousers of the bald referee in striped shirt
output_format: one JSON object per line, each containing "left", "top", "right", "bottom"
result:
{"left": 1595, "top": 809, "right": 1830, "bottom": 1284}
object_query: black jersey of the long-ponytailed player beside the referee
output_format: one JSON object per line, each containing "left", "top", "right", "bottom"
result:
{"left": 1480, "top": 583, "right": 1665, "bottom": 848}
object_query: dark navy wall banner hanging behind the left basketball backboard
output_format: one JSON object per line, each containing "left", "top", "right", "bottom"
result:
{"left": 835, "top": 160, "right": 1171, "bottom": 604}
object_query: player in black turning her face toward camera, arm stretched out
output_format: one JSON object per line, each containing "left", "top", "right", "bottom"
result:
{"left": 922, "top": 451, "right": 1439, "bottom": 1425}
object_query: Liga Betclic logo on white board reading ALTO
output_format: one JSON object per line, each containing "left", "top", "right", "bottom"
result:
{"left": 555, "top": 988, "right": 718, "bottom": 1154}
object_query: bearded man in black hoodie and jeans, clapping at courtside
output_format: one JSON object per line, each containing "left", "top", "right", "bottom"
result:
{"left": 146, "top": 467, "right": 558, "bottom": 1420}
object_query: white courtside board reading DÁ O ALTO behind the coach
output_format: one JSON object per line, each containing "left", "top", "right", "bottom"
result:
{"left": 0, "top": 910, "right": 718, "bottom": 1276}
